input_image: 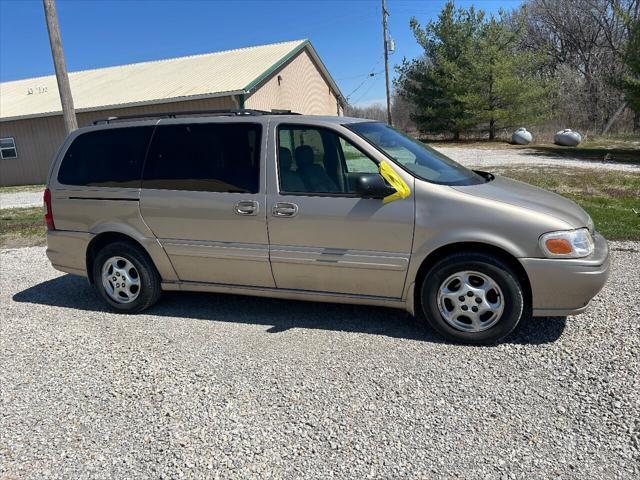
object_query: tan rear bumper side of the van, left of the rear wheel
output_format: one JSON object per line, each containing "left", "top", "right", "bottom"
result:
{"left": 47, "top": 230, "right": 93, "bottom": 277}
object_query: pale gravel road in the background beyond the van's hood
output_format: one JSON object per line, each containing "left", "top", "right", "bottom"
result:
{"left": 438, "top": 147, "right": 640, "bottom": 173}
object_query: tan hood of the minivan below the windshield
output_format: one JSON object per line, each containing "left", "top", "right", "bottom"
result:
{"left": 453, "top": 175, "right": 590, "bottom": 228}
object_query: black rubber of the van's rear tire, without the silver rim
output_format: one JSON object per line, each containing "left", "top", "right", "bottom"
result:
{"left": 93, "top": 241, "right": 162, "bottom": 313}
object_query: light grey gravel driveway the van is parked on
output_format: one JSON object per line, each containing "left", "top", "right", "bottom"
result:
{"left": 0, "top": 246, "right": 640, "bottom": 479}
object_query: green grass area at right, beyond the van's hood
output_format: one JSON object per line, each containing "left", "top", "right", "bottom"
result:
{"left": 491, "top": 167, "right": 640, "bottom": 240}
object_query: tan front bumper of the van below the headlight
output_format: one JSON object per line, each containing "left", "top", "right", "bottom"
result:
{"left": 520, "top": 233, "right": 609, "bottom": 317}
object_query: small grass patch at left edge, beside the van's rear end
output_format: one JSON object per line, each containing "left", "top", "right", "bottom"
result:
{"left": 0, "top": 207, "right": 46, "bottom": 248}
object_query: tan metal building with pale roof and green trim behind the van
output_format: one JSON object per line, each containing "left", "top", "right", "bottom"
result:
{"left": 0, "top": 40, "right": 343, "bottom": 186}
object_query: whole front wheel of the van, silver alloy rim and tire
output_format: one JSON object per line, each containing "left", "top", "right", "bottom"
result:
{"left": 420, "top": 253, "right": 524, "bottom": 344}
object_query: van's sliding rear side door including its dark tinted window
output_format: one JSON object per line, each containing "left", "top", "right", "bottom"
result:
{"left": 140, "top": 119, "right": 275, "bottom": 287}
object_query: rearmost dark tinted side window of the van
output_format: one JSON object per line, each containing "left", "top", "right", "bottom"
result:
{"left": 58, "top": 127, "right": 153, "bottom": 188}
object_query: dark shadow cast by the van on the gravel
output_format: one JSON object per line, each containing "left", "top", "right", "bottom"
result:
{"left": 13, "top": 275, "right": 566, "bottom": 345}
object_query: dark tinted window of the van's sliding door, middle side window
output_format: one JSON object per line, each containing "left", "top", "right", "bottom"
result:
{"left": 142, "top": 123, "right": 261, "bottom": 193}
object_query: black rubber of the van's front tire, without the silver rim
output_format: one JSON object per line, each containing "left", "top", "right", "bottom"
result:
{"left": 420, "top": 253, "right": 527, "bottom": 345}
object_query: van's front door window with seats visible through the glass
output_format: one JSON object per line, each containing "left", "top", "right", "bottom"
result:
{"left": 278, "top": 125, "right": 378, "bottom": 194}
